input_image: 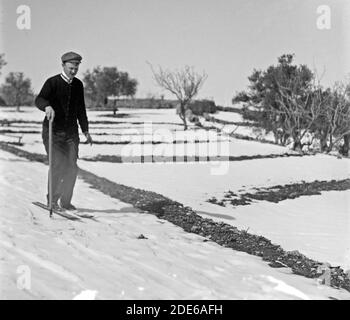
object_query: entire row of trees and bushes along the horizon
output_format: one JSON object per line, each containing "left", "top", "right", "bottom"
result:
{"left": 0, "top": 54, "right": 350, "bottom": 155}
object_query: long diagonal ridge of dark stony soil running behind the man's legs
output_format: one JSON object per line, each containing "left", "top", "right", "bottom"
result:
{"left": 0, "top": 142, "right": 350, "bottom": 292}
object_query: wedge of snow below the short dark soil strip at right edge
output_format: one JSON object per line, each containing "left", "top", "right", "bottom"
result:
{"left": 226, "top": 190, "right": 350, "bottom": 270}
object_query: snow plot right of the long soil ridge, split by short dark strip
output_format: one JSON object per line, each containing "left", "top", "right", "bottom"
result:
{"left": 79, "top": 155, "right": 350, "bottom": 269}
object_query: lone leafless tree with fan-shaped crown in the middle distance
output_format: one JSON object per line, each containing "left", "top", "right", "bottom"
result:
{"left": 150, "top": 64, "right": 207, "bottom": 130}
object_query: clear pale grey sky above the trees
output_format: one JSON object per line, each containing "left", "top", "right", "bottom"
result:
{"left": 0, "top": 0, "right": 350, "bottom": 106}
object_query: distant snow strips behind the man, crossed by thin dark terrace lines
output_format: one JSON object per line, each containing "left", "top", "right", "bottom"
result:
{"left": 0, "top": 108, "right": 289, "bottom": 158}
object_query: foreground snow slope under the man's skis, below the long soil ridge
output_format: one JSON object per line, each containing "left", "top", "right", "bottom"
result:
{"left": 0, "top": 151, "right": 350, "bottom": 300}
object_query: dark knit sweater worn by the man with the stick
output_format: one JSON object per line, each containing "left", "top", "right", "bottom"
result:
{"left": 35, "top": 74, "right": 89, "bottom": 134}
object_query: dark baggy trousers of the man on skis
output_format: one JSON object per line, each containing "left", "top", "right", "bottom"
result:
{"left": 42, "top": 127, "right": 79, "bottom": 205}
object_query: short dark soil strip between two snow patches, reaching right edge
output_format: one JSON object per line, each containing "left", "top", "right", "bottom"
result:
{"left": 208, "top": 179, "right": 350, "bottom": 206}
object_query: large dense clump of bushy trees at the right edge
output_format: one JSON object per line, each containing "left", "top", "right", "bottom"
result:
{"left": 232, "top": 54, "right": 350, "bottom": 155}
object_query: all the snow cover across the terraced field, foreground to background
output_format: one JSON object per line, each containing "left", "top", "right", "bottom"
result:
{"left": 0, "top": 108, "right": 350, "bottom": 299}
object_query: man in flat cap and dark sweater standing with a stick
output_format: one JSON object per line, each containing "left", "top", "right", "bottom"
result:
{"left": 35, "top": 52, "right": 92, "bottom": 210}
